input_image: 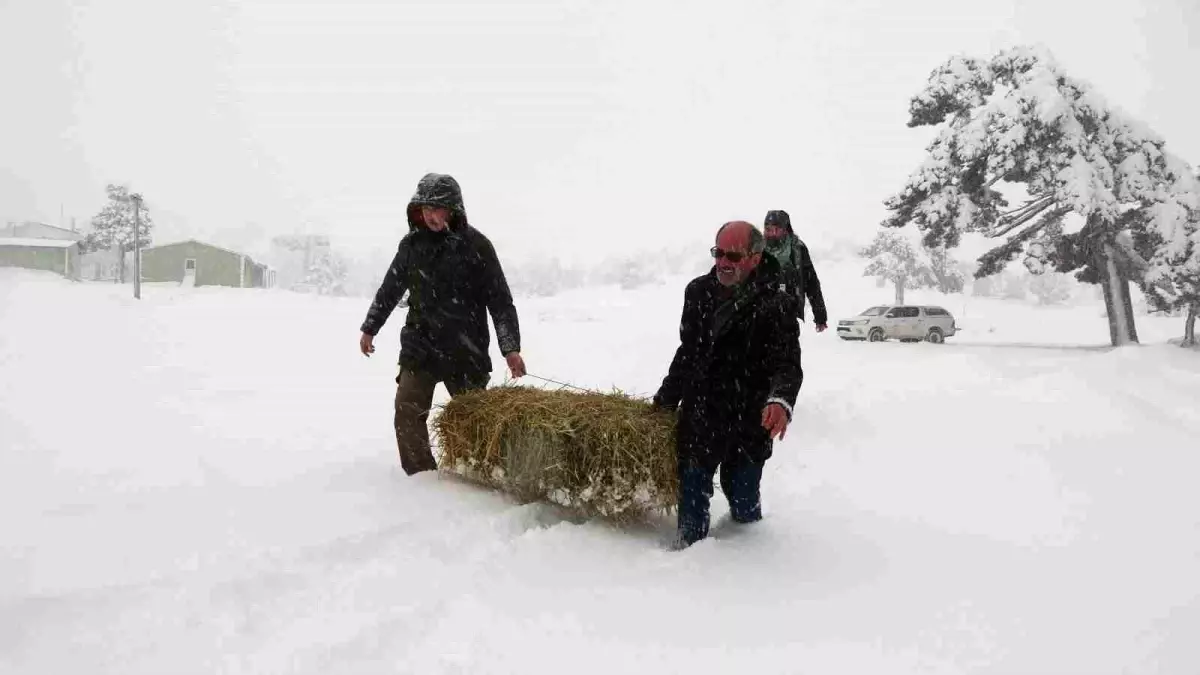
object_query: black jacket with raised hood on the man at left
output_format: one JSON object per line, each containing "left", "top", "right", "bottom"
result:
{"left": 361, "top": 173, "right": 521, "bottom": 378}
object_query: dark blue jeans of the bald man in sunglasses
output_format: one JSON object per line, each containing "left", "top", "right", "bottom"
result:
{"left": 678, "top": 453, "right": 763, "bottom": 545}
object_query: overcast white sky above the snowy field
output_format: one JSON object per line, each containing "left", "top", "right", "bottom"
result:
{"left": 0, "top": 0, "right": 1200, "bottom": 263}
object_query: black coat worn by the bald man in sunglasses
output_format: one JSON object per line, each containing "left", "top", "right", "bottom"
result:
{"left": 654, "top": 253, "right": 804, "bottom": 464}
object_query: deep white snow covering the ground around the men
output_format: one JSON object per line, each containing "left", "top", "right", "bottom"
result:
{"left": 0, "top": 265, "right": 1200, "bottom": 675}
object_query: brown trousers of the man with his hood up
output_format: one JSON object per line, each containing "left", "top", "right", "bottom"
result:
{"left": 396, "top": 369, "right": 490, "bottom": 476}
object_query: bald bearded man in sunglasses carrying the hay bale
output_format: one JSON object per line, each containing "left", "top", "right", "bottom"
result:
{"left": 653, "top": 221, "right": 804, "bottom": 548}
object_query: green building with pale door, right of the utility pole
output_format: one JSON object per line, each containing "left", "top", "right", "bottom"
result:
{"left": 142, "top": 239, "right": 275, "bottom": 288}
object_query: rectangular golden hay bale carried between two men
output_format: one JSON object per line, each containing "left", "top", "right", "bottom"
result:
{"left": 433, "top": 384, "right": 678, "bottom": 520}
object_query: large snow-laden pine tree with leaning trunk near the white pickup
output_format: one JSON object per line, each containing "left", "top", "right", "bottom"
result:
{"left": 883, "top": 47, "right": 1200, "bottom": 345}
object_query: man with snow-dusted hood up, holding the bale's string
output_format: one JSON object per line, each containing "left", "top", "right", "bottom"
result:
{"left": 359, "top": 173, "right": 526, "bottom": 476}
